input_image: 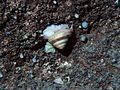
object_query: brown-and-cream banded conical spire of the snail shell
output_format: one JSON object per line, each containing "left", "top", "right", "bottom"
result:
{"left": 48, "top": 29, "right": 71, "bottom": 49}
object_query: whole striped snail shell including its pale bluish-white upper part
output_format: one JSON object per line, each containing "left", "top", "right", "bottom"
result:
{"left": 43, "top": 24, "right": 73, "bottom": 49}
